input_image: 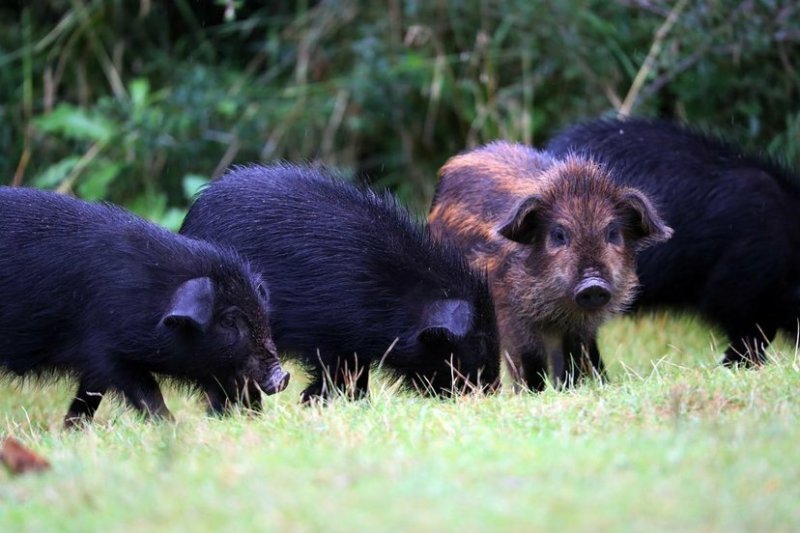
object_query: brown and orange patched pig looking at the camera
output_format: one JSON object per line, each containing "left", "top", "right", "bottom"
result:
{"left": 428, "top": 141, "right": 670, "bottom": 390}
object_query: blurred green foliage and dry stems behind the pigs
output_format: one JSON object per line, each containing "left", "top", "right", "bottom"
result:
{"left": 0, "top": 0, "right": 800, "bottom": 223}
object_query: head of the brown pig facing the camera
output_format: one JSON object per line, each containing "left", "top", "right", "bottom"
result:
{"left": 499, "top": 160, "right": 671, "bottom": 325}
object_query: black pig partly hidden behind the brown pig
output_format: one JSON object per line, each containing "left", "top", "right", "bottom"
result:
{"left": 548, "top": 119, "right": 800, "bottom": 365}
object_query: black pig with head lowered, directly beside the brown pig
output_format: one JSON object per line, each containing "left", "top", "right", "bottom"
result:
{"left": 181, "top": 164, "right": 499, "bottom": 400}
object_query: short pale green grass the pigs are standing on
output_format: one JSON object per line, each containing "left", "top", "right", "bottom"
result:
{"left": 0, "top": 315, "right": 800, "bottom": 531}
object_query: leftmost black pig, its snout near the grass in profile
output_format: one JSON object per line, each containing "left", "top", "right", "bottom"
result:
{"left": 0, "top": 187, "right": 288, "bottom": 425}
